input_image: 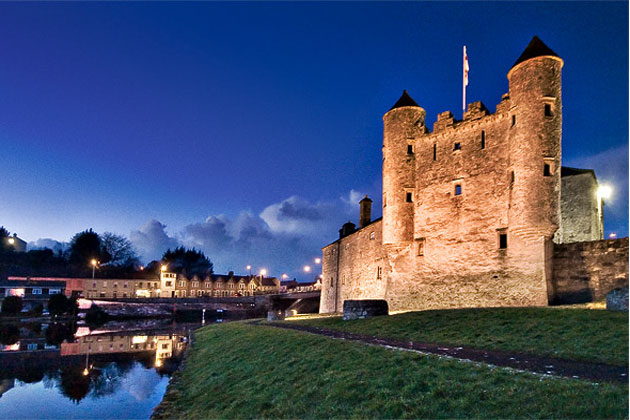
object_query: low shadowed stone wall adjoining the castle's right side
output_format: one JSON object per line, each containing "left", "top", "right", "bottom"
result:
{"left": 549, "top": 238, "right": 628, "bottom": 304}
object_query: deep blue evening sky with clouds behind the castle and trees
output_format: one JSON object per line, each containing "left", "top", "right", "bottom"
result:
{"left": 0, "top": 2, "right": 628, "bottom": 280}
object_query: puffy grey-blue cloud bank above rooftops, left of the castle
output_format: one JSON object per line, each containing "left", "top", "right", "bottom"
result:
{"left": 130, "top": 190, "right": 376, "bottom": 279}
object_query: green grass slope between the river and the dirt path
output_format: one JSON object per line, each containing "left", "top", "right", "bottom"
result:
{"left": 160, "top": 323, "right": 628, "bottom": 419}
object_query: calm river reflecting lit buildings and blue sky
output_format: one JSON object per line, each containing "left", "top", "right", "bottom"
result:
{"left": 0, "top": 320, "right": 200, "bottom": 419}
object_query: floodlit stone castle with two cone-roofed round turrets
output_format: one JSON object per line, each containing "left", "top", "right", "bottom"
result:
{"left": 320, "top": 37, "right": 628, "bottom": 313}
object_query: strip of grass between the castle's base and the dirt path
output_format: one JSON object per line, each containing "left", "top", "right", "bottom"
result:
{"left": 294, "top": 308, "right": 628, "bottom": 365}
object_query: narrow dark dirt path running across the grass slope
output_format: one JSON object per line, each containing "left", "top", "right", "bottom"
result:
{"left": 255, "top": 322, "right": 628, "bottom": 383}
